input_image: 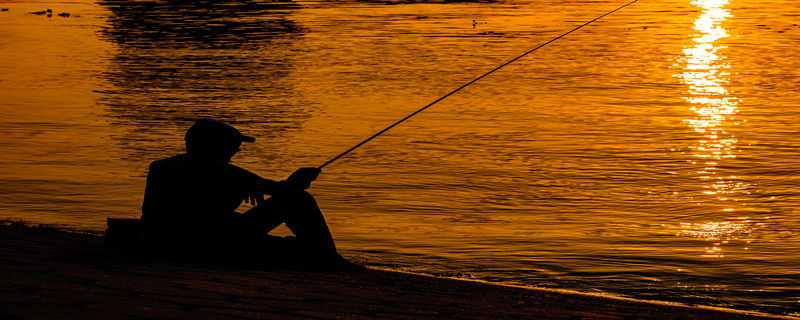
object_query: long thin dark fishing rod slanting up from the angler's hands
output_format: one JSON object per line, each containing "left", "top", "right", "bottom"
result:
{"left": 317, "top": 0, "right": 639, "bottom": 169}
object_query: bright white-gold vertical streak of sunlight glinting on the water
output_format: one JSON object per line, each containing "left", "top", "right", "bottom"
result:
{"left": 675, "top": 0, "right": 753, "bottom": 258}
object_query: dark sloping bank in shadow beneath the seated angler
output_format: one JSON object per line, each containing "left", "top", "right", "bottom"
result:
{"left": 0, "top": 223, "right": 797, "bottom": 319}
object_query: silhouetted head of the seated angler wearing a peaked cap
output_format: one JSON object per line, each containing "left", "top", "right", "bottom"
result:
{"left": 184, "top": 119, "right": 256, "bottom": 162}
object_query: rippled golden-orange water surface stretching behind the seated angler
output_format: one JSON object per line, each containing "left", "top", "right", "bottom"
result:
{"left": 0, "top": 0, "right": 800, "bottom": 313}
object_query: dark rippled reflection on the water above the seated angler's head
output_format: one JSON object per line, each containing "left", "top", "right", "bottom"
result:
{"left": 96, "top": 0, "right": 313, "bottom": 161}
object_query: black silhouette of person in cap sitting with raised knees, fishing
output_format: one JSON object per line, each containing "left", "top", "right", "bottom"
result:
{"left": 142, "top": 119, "right": 355, "bottom": 268}
